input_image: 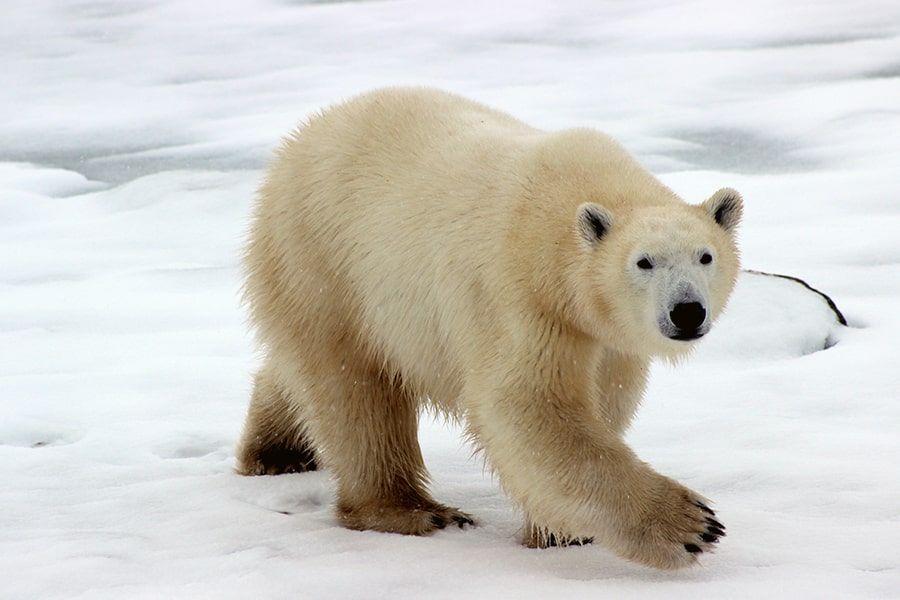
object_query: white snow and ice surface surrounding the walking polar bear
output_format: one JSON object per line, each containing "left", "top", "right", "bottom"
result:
{"left": 0, "top": 0, "right": 900, "bottom": 600}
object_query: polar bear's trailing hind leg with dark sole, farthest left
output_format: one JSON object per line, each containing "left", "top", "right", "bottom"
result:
{"left": 237, "top": 368, "right": 318, "bottom": 475}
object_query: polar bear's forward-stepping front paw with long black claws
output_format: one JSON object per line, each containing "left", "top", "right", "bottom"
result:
{"left": 625, "top": 477, "right": 725, "bottom": 569}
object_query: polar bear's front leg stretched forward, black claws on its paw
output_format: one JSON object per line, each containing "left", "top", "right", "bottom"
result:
{"left": 466, "top": 354, "right": 725, "bottom": 569}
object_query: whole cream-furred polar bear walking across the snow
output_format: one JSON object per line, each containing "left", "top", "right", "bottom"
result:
{"left": 237, "top": 88, "right": 742, "bottom": 568}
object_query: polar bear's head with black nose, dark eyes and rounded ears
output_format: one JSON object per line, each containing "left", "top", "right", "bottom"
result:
{"left": 574, "top": 188, "right": 743, "bottom": 359}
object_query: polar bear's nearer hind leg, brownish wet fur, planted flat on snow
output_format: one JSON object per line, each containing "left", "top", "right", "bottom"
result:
{"left": 304, "top": 354, "right": 473, "bottom": 535}
